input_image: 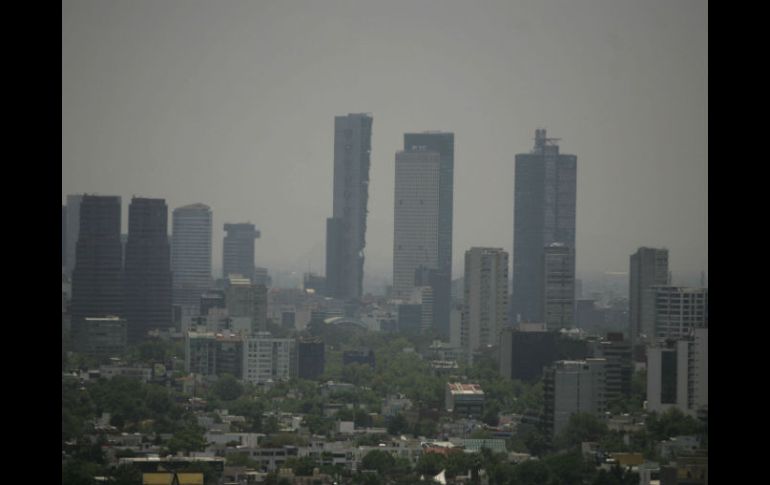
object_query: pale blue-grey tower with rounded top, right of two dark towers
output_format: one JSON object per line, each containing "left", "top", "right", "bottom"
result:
{"left": 171, "top": 204, "right": 212, "bottom": 313}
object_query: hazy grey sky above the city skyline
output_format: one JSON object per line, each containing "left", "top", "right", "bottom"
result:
{"left": 62, "top": 0, "right": 708, "bottom": 286}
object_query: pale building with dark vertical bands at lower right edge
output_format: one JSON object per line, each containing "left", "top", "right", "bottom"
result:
{"left": 647, "top": 328, "right": 708, "bottom": 416}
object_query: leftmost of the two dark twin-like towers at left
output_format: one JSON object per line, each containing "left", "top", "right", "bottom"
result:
{"left": 67, "top": 195, "right": 123, "bottom": 345}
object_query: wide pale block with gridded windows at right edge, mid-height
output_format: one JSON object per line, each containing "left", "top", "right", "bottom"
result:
{"left": 649, "top": 286, "right": 708, "bottom": 340}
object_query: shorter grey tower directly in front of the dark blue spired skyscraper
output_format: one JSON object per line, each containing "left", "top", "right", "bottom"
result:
{"left": 543, "top": 243, "right": 575, "bottom": 330}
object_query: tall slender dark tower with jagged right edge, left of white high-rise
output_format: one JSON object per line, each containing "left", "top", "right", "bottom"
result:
{"left": 326, "top": 114, "right": 372, "bottom": 300}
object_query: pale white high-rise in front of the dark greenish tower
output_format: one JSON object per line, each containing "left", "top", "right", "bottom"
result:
{"left": 393, "top": 147, "right": 440, "bottom": 300}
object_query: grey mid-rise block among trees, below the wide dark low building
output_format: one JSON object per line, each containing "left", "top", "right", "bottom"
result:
{"left": 543, "top": 359, "right": 607, "bottom": 437}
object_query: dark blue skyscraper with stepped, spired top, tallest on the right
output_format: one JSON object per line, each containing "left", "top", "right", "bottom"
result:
{"left": 511, "top": 129, "right": 577, "bottom": 322}
